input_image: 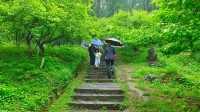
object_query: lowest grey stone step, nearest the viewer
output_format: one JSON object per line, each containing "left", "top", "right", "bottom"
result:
{"left": 70, "top": 101, "right": 122, "bottom": 110}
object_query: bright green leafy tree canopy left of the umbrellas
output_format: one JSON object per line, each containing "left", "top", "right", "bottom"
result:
{"left": 0, "top": 0, "right": 89, "bottom": 56}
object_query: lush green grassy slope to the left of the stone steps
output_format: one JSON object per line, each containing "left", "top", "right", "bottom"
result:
{"left": 0, "top": 47, "right": 86, "bottom": 112}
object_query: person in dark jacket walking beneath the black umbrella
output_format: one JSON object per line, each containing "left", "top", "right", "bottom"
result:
{"left": 104, "top": 43, "right": 116, "bottom": 78}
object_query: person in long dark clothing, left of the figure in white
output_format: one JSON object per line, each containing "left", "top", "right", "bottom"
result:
{"left": 88, "top": 44, "right": 96, "bottom": 65}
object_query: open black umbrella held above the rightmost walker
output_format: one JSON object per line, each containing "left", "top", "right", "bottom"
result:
{"left": 105, "top": 38, "right": 123, "bottom": 47}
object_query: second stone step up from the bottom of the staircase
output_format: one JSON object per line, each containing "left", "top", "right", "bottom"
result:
{"left": 73, "top": 93, "right": 124, "bottom": 101}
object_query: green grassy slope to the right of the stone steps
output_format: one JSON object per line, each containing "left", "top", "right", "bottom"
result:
{"left": 119, "top": 48, "right": 200, "bottom": 112}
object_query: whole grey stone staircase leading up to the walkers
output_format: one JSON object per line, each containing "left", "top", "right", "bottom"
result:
{"left": 69, "top": 63, "right": 124, "bottom": 112}
